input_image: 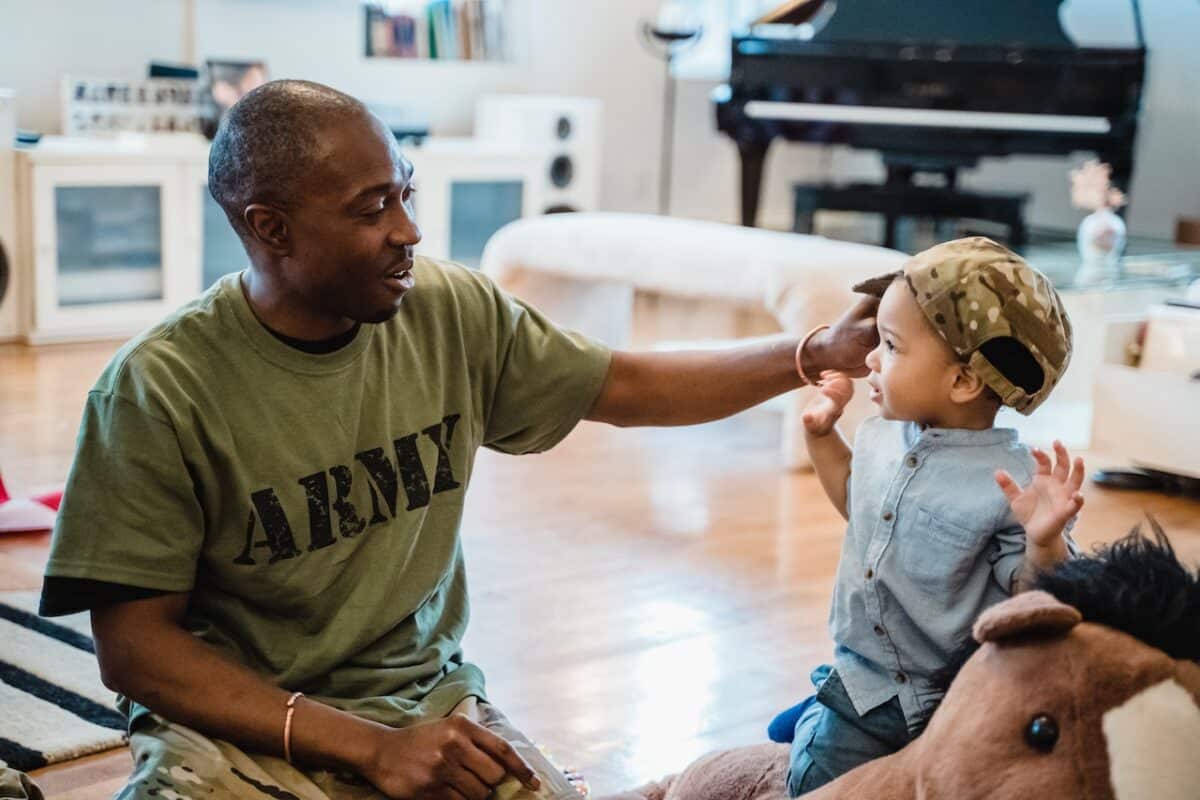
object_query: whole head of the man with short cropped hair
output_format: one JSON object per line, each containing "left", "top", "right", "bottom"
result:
{"left": 209, "top": 80, "right": 421, "bottom": 331}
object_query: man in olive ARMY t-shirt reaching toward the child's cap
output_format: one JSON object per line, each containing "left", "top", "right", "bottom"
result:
{"left": 42, "top": 82, "right": 876, "bottom": 800}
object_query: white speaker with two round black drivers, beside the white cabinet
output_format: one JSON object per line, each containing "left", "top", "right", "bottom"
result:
{"left": 475, "top": 95, "right": 604, "bottom": 213}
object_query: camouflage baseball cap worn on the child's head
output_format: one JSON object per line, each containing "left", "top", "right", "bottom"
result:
{"left": 854, "top": 236, "right": 1072, "bottom": 414}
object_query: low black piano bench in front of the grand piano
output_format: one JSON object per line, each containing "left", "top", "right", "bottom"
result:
{"left": 792, "top": 184, "right": 1030, "bottom": 247}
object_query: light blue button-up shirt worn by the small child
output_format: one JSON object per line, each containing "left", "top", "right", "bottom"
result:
{"left": 829, "top": 417, "right": 1074, "bottom": 729}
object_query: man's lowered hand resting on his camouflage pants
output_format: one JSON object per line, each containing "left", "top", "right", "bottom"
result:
{"left": 359, "top": 714, "right": 541, "bottom": 800}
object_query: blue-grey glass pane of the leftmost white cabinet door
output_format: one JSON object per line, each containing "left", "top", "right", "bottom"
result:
{"left": 54, "top": 185, "right": 163, "bottom": 307}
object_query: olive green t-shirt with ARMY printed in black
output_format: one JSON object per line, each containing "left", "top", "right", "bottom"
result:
{"left": 46, "top": 259, "right": 610, "bottom": 726}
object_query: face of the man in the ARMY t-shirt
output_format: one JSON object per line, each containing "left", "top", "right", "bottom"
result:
{"left": 284, "top": 115, "right": 421, "bottom": 323}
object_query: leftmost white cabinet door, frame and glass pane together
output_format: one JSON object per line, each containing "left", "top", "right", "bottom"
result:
{"left": 31, "top": 164, "right": 192, "bottom": 339}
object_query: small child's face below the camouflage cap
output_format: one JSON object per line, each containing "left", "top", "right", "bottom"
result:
{"left": 866, "top": 278, "right": 962, "bottom": 426}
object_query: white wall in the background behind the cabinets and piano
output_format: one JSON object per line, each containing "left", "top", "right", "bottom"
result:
{"left": 0, "top": 0, "right": 1200, "bottom": 235}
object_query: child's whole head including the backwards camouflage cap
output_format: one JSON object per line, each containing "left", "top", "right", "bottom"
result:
{"left": 856, "top": 237, "right": 1072, "bottom": 425}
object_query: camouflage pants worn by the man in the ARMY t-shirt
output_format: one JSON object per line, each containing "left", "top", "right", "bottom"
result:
{"left": 114, "top": 697, "right": 580, "bottom": 800}
